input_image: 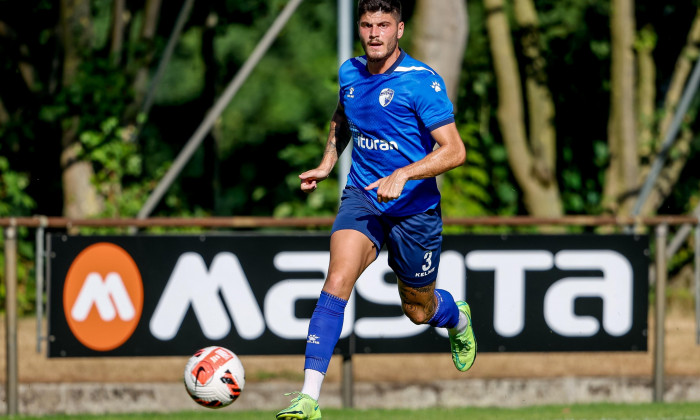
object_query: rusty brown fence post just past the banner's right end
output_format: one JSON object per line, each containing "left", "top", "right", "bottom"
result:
{"left": 654, "top": 224, "right": 668, "bottom": 402}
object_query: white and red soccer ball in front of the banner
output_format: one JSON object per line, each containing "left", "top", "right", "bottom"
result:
{"left": 185, "top": 346, "right": 245, "bottom": 408}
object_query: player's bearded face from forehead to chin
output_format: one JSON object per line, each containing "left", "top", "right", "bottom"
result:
{"left": 358, "top": 11, "right": 404, "bottom": 62}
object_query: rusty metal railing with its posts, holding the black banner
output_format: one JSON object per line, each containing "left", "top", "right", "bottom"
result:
{"left": 0, "top": 215, "right": 700, "bottom": 415}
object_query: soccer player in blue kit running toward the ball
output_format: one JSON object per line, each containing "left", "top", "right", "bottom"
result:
{"left": 277, "top": 0, "right": 476, "bottom": 419}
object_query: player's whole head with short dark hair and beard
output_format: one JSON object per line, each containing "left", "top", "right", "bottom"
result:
{"left": 357, "top": 0, "right": 404, "bottom": 63}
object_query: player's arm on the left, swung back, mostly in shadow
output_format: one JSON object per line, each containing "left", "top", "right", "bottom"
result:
{"left": 299, "top": 104, "right": 350, "bottom": 193}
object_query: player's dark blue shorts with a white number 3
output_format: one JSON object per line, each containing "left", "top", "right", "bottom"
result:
{"left": 331, "top": 187, "right": 442, "bottom": 288}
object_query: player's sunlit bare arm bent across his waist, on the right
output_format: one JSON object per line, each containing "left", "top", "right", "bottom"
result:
{"left": 365, "top": 123, "right": 467, "bottom": 202}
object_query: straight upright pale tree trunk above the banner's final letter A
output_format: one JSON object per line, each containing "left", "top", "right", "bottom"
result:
{"left": 604, "top": 0, "right": 639, "bottom": 214}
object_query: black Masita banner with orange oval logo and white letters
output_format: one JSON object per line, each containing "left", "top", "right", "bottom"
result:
{"left": 47, "top": 234, "right": 649, "bottom": 357}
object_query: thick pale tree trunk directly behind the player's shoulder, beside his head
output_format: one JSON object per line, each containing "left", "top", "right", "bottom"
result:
{"left": 411, "top": 0, "right": 469, "bottom": 103}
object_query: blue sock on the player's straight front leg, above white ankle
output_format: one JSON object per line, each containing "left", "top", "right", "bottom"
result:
{"left": 304, "top": 292, "right": 348, "bottom": 374}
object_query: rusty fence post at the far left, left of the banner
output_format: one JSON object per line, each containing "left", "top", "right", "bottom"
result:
{"left": 5, "top": 223, "right": 19, "bottom": 416}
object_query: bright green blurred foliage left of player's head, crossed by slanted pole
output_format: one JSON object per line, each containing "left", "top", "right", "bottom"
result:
{"left": 215, "top": 2, "right": 337, "bottom": 153}
